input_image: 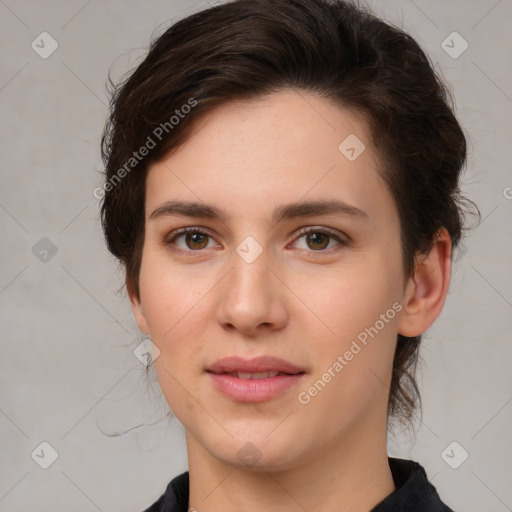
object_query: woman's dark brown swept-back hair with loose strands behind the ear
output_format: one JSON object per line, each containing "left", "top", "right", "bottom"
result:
{"left": 101, "top": 0, "right": 480, "bottom": 430}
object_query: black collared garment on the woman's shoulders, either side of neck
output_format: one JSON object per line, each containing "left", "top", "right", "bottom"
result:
{"left": 144, "top": 457, "right": 453, "bottom": 512}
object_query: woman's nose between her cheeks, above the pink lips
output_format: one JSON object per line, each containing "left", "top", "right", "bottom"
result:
{"left": 217, "top": 247, "right": 288, "bottom": 337}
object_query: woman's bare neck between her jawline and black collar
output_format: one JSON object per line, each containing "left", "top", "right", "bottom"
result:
{"left": 186, "top": 414, "right": 395, "bottom": 512}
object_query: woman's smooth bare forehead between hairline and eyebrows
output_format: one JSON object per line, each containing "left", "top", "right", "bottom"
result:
{"left": 146, "top": 90, "right": 392, "bottom": 228}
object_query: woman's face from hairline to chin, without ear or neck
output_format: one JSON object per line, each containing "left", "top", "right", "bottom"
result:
{"left": 132, "top": 91, "right": 405, "bottom": 470}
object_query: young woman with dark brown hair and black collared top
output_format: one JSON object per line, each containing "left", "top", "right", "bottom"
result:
{"left": 102, "top": 0, "right": 476, "bottom": 512}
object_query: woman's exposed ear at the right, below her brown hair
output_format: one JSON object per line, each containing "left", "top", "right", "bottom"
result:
{"left": 398, "top": 228, "right": 452, "bottom": 337}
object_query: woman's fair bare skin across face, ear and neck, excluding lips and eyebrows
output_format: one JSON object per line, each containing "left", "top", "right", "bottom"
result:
{"left": 131, "top": 90, "right": 451, "bottom": 512}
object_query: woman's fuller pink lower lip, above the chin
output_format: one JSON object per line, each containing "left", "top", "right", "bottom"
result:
{"left": 208, "top": 372, "right": 304, "bottom": 402}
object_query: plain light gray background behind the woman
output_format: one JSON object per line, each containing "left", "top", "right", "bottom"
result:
{"left": 0, "top": 0, "right": 512, "bottom": 512}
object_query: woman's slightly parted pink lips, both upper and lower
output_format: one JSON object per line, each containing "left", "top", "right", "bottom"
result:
{"left": 206, "top": 356, "right": 305, "bottom": 402}
